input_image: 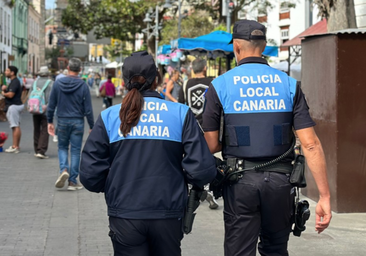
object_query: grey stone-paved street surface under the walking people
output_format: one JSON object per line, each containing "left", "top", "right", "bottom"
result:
{"left": 0, "top": 93, "right": 366, "bottom": 256}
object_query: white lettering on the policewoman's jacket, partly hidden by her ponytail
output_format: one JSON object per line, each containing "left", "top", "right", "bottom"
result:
{"left": 118, "top": 101, "right": 170, "bottom": 138}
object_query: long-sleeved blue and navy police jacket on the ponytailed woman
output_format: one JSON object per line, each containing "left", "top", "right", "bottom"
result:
{"left": 80, "top": 91, "right": 216, "bottom": 219}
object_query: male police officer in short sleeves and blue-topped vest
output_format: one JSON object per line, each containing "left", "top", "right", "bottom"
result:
{"left": 203, "top": 20, "right": 332, "bottom": 256}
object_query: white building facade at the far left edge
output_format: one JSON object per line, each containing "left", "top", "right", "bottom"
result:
{"left": 0, "top": 0, "right": 13, "bottom": 73}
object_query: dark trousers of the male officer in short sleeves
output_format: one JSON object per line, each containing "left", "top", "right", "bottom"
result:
{"left": 223, "top": 172, "right": 295, "bottom": 256}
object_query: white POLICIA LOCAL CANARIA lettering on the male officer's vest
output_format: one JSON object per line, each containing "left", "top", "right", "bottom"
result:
{"left": 233, "top": 75, "right": 286, "bottom": 111}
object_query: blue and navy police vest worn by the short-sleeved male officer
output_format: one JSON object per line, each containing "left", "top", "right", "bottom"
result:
{"left": 212, "top": 63, "right": 296, "bottom": 159}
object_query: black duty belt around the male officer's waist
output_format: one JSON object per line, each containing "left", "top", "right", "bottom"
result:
{"left": 227, "top": 158, "right": 293, "bottom": 174}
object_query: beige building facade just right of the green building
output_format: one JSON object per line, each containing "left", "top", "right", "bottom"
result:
{"left": 28, "top": 5, "right": 41, "bottom": 74}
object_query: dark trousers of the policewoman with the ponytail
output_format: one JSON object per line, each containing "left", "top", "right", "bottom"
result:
{"left": 109, "top": 217, "right": 183, "bottom": 256}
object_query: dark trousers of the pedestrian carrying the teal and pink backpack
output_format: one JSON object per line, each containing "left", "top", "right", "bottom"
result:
{"left": 33, "top": 114, "right": 49, "bottom": 155}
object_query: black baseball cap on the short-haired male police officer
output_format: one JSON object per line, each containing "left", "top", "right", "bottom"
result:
{"left": 229, "top": 20, "right": 266, "bottom": 44}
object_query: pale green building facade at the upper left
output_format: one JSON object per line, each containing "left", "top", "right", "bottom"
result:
{"left": 10, "top": 0, "right": 29, "bottom": 74}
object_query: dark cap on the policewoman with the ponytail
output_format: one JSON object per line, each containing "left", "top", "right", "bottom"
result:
{"left": 122, "top": 51, "right": 157, "bottom": 90}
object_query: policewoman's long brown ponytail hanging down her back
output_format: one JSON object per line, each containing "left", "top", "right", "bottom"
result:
{"left": 119, "top": 76, "right": 146, "bottom": 137}
